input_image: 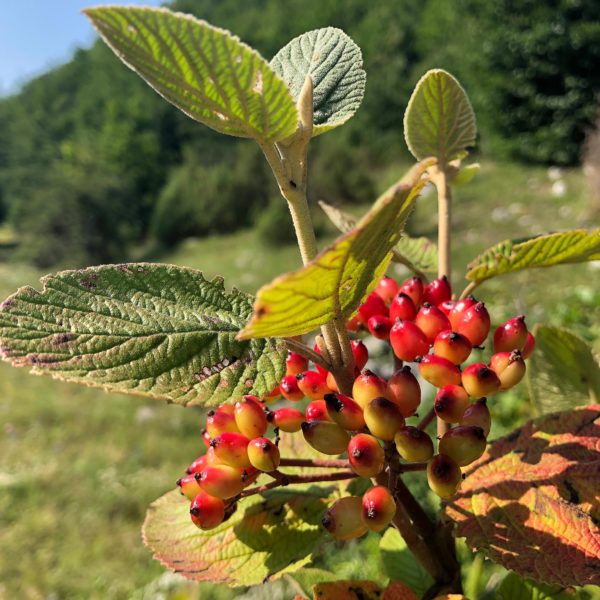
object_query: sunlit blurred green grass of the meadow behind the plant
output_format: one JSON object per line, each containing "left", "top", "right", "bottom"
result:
{"left": 0, "top": 162, "right": 600, "bottom": 600}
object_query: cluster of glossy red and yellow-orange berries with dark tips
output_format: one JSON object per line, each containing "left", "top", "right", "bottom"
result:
{"left": 177, "top": 277, "right": 535, "bottom": 540}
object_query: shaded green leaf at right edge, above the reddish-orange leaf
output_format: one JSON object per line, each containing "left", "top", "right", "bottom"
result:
{"left": 527, "top": 325, "right": 600, "bottom": 414}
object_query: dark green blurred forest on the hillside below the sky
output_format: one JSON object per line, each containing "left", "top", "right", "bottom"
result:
{"left": 0, "top": 0, "right": 600, "bottom": 268}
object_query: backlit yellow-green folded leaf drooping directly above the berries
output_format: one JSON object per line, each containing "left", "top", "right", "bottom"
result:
{"left": 240, "top": 162, "right": 431, "bottom": 338}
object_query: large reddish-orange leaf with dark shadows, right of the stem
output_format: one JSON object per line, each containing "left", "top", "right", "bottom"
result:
{"left": 446, "top": 405, "right": 600, "bottom": 586}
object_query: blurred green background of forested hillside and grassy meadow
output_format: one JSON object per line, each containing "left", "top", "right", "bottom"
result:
{"left": 0, "top": 0, "right": 600, "bottom": 600}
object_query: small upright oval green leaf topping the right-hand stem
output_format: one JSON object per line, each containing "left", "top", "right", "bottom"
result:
{"left": 404, "top": 69, "right": 477, "bottom": 167}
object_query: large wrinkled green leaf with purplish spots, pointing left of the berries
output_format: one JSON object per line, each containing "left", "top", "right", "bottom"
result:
{"left": 0, "top": 263, "right": 286, "bottom": 406}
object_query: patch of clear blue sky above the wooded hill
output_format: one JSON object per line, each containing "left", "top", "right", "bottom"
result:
{"left": 0, "top": 0, "right": 162, "bottom": 96}
